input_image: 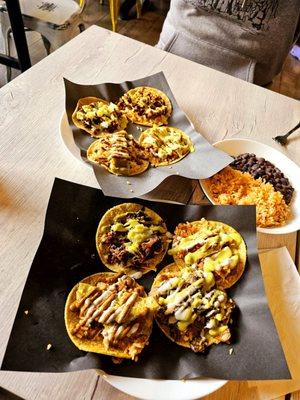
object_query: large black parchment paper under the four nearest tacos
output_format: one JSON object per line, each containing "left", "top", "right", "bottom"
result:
{"left": 2, "top": 179, "right": 290, "bottom": 380}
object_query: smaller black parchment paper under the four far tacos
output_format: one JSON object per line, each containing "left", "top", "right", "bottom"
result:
{"left": 64, "top": 72, "right": 232, "bottom": 198}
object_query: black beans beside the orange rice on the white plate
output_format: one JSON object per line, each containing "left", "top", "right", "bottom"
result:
{"left": 230, "top": 153, "right": 294, "bottom": 204}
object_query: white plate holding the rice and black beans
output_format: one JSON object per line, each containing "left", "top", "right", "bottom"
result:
{"left": 200, "top": 139, "right": 300, "bottom": 234}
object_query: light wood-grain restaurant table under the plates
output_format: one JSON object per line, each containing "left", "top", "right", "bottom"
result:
{"left": 0, "top": 26, "right": 300, "bottom": 400}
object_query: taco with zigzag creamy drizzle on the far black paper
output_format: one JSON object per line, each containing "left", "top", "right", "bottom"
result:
{"left": 87, "top": 131, "right": 149, "bottom": 176}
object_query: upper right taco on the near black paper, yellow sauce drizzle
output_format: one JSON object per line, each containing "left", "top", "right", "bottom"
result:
{"left": 169, "top": 218, "right": 247, "bottom": 289}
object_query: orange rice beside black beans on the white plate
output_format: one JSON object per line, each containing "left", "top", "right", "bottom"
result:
{"left": 206, "top": 167, "right": 290, "bottom": 227}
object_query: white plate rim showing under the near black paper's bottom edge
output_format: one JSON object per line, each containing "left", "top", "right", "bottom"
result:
{"left": 99, "top": 371, "right": 227, "bottom": 400}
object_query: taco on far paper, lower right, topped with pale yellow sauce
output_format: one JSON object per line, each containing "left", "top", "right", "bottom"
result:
{"left": 139, "top": 126, "right": 194, "bottom": 167}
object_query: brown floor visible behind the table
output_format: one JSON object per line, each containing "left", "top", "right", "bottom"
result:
{"left": 0, "top": 0, "right": 300, "bottom": 100}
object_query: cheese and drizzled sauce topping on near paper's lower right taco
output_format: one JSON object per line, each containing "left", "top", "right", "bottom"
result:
{"left": 154, "top": 266, "right": 233, "bottom": 344}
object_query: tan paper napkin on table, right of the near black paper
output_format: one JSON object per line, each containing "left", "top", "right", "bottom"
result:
{"left": 248, "top": 247, "right": 300, "bottom": 400}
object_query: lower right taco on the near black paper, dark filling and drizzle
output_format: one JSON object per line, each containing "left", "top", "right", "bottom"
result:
{"left": 149, "top": 264, "right": 235, "bottom": 353}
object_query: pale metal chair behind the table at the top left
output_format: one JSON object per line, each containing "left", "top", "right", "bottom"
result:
{"left": 0, "top": 0, "right": 85, "bottom": 81}
